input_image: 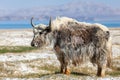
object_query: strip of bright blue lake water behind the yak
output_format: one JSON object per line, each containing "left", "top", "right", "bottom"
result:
{"left": 0, "top": 21, "right": 120, "bottom": 29}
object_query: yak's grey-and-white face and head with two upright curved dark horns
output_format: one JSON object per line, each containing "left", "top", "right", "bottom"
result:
{"left": 31, "top": 17, "right": 51, "bottom": 47}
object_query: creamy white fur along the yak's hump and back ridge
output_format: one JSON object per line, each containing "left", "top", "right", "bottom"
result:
{"left": 51, "top": 17, "right": 109, "bottom": 31}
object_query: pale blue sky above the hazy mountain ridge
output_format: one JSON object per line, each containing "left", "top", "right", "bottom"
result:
{"left": 0, "top": 0, "right": 120, "bottom": 10}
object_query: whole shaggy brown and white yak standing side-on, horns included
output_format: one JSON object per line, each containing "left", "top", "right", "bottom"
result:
{"left": 31, "top": 17, "right": 112, "bottom": 77}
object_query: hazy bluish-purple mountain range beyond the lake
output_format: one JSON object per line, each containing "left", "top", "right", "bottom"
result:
{"left": 0, "top": 2, "right": 120, "bottom": 20}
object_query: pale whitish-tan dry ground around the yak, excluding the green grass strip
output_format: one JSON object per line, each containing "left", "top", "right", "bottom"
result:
{"left": 0, "top": 28, "right": 120, "bottom": 80}
